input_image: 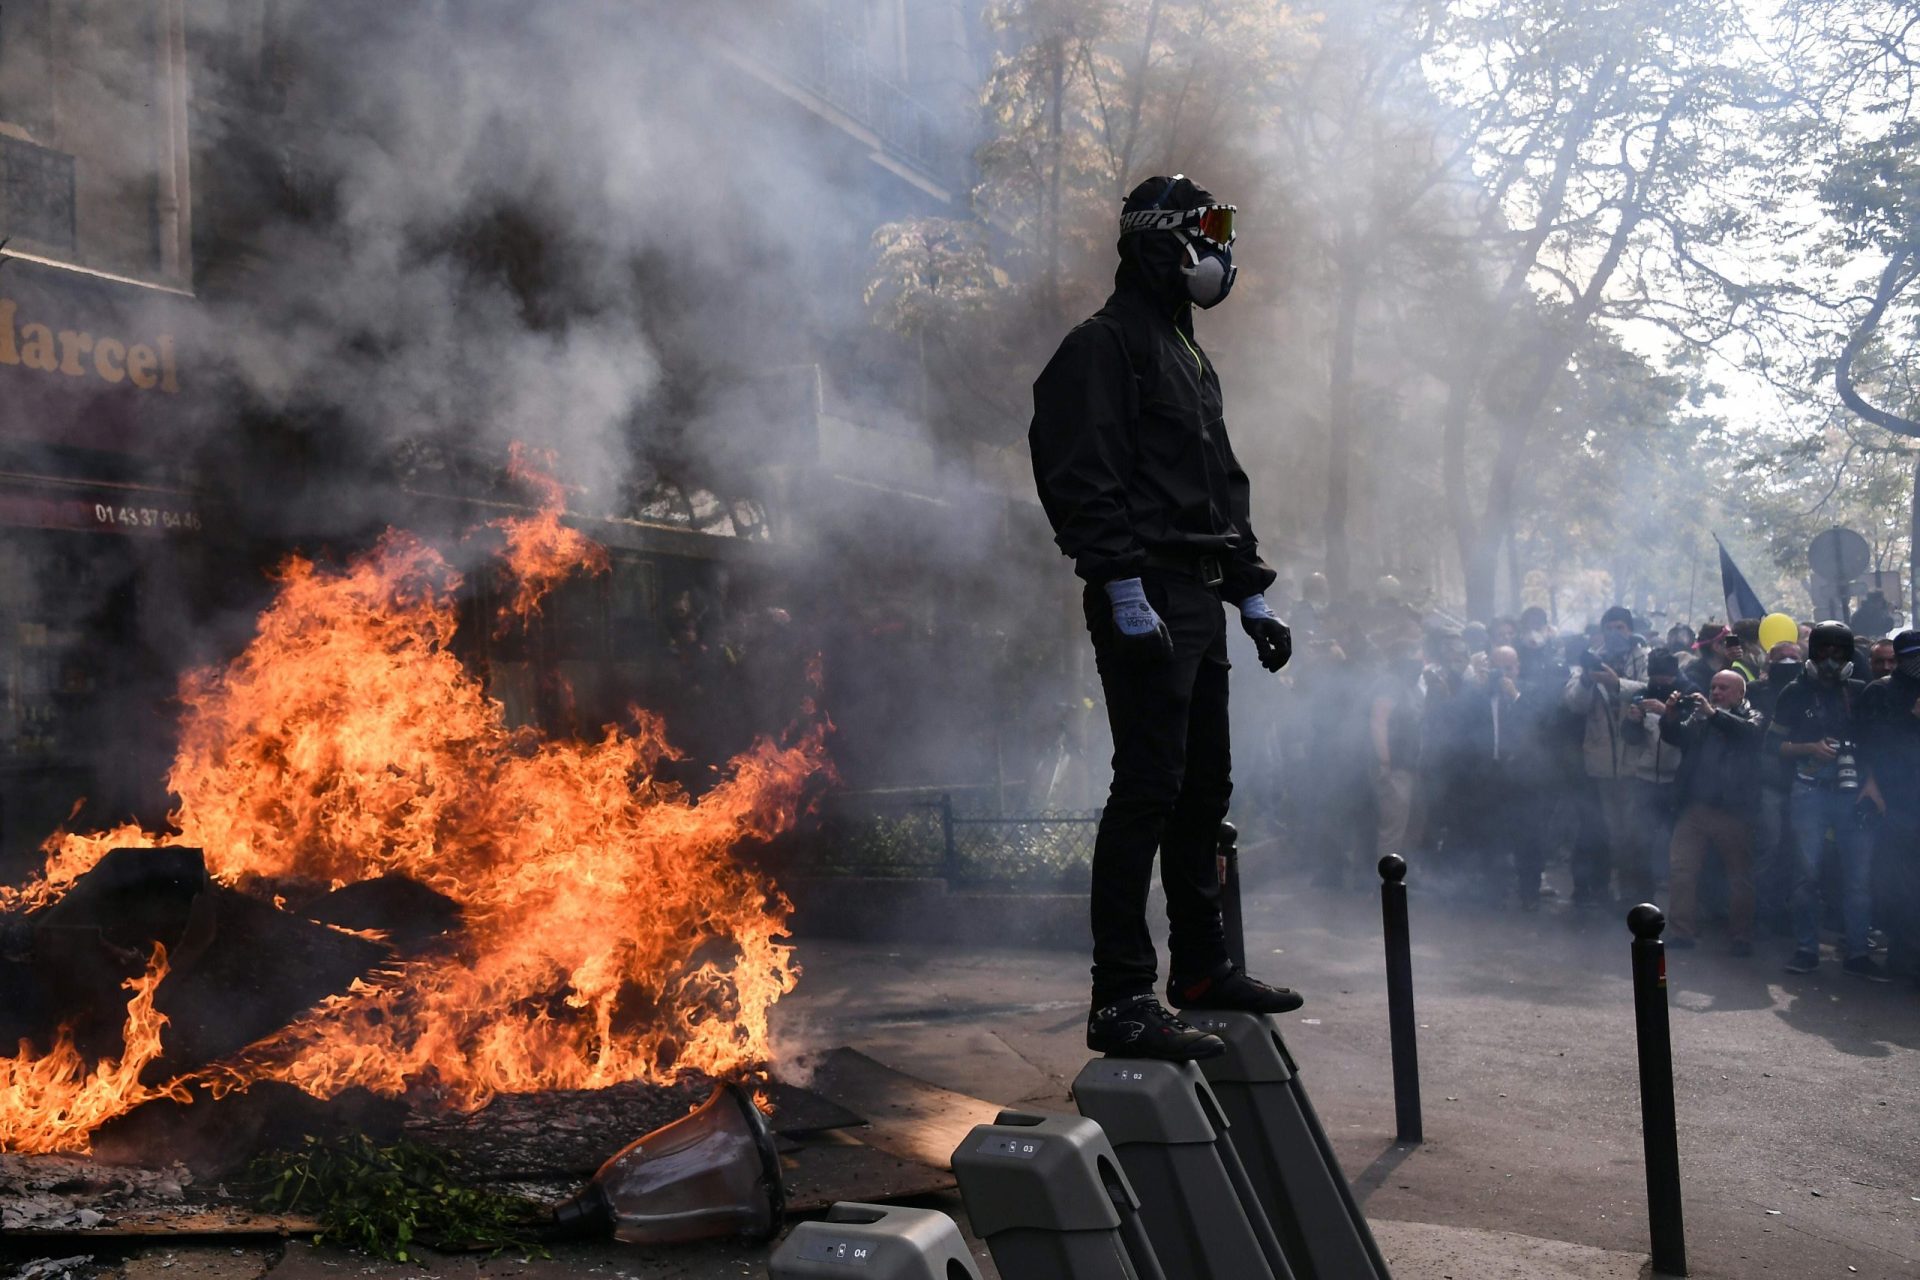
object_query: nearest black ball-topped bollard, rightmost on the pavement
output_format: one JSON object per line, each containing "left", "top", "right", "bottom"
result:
{"left": 1626, "top": 902, "right": 1686, "bottom": 1276}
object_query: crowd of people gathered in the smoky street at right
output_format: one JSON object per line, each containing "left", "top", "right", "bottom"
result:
{"left": 1279, "top": 581, "right": 1920, "bottom": 984}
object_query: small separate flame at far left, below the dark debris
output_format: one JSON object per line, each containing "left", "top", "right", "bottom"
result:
{"left": 0, "top": 946, "right": 184, "bottom": 1153}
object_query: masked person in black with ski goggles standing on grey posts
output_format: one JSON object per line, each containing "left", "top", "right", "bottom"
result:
{"left": 1027, "top": 175, "right": 1302, "bottom": 1059}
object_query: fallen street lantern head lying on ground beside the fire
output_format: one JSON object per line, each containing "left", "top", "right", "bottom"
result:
{"left": 553, "top": 1084, "right": 787, "bottom": 1244}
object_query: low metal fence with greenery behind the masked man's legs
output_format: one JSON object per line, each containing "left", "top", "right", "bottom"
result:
{"left": 783, "top": 789, "right": 1100, "bottom": 890}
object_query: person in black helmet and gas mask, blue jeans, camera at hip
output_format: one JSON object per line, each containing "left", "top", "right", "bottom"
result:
{"left": 1766, "top": 622, "right": 1885, "bottom": 981}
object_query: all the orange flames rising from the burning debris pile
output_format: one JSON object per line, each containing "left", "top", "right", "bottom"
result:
{"left": 0, "top": 460, "right": 826, "bottom": 1150}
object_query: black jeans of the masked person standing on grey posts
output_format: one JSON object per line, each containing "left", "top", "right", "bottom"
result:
{"left": 1085, "top": 570, "right": 1233, "bottom": 1006}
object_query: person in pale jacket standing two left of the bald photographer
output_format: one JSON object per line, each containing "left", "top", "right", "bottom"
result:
{"left": 1561, "top": 604, "right": 1651, "bottom": 908}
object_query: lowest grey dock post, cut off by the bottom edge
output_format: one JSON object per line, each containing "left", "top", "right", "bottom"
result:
{"left": 768, "top": 1201, "right": 979, "bottom": 1280}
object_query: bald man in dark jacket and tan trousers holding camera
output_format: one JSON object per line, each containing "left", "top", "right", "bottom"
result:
{"left": 1649, "top": 672, "right": 1764, "bottom": 956}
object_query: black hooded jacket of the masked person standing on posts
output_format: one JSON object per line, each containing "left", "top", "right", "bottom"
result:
{"left": 1027, "top": 263, "right": 1275, "bottom": 601}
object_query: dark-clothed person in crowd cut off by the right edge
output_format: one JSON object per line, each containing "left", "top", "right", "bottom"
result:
{"left": 1860, "top": 631, "right": 1920, "bottom": 983}
